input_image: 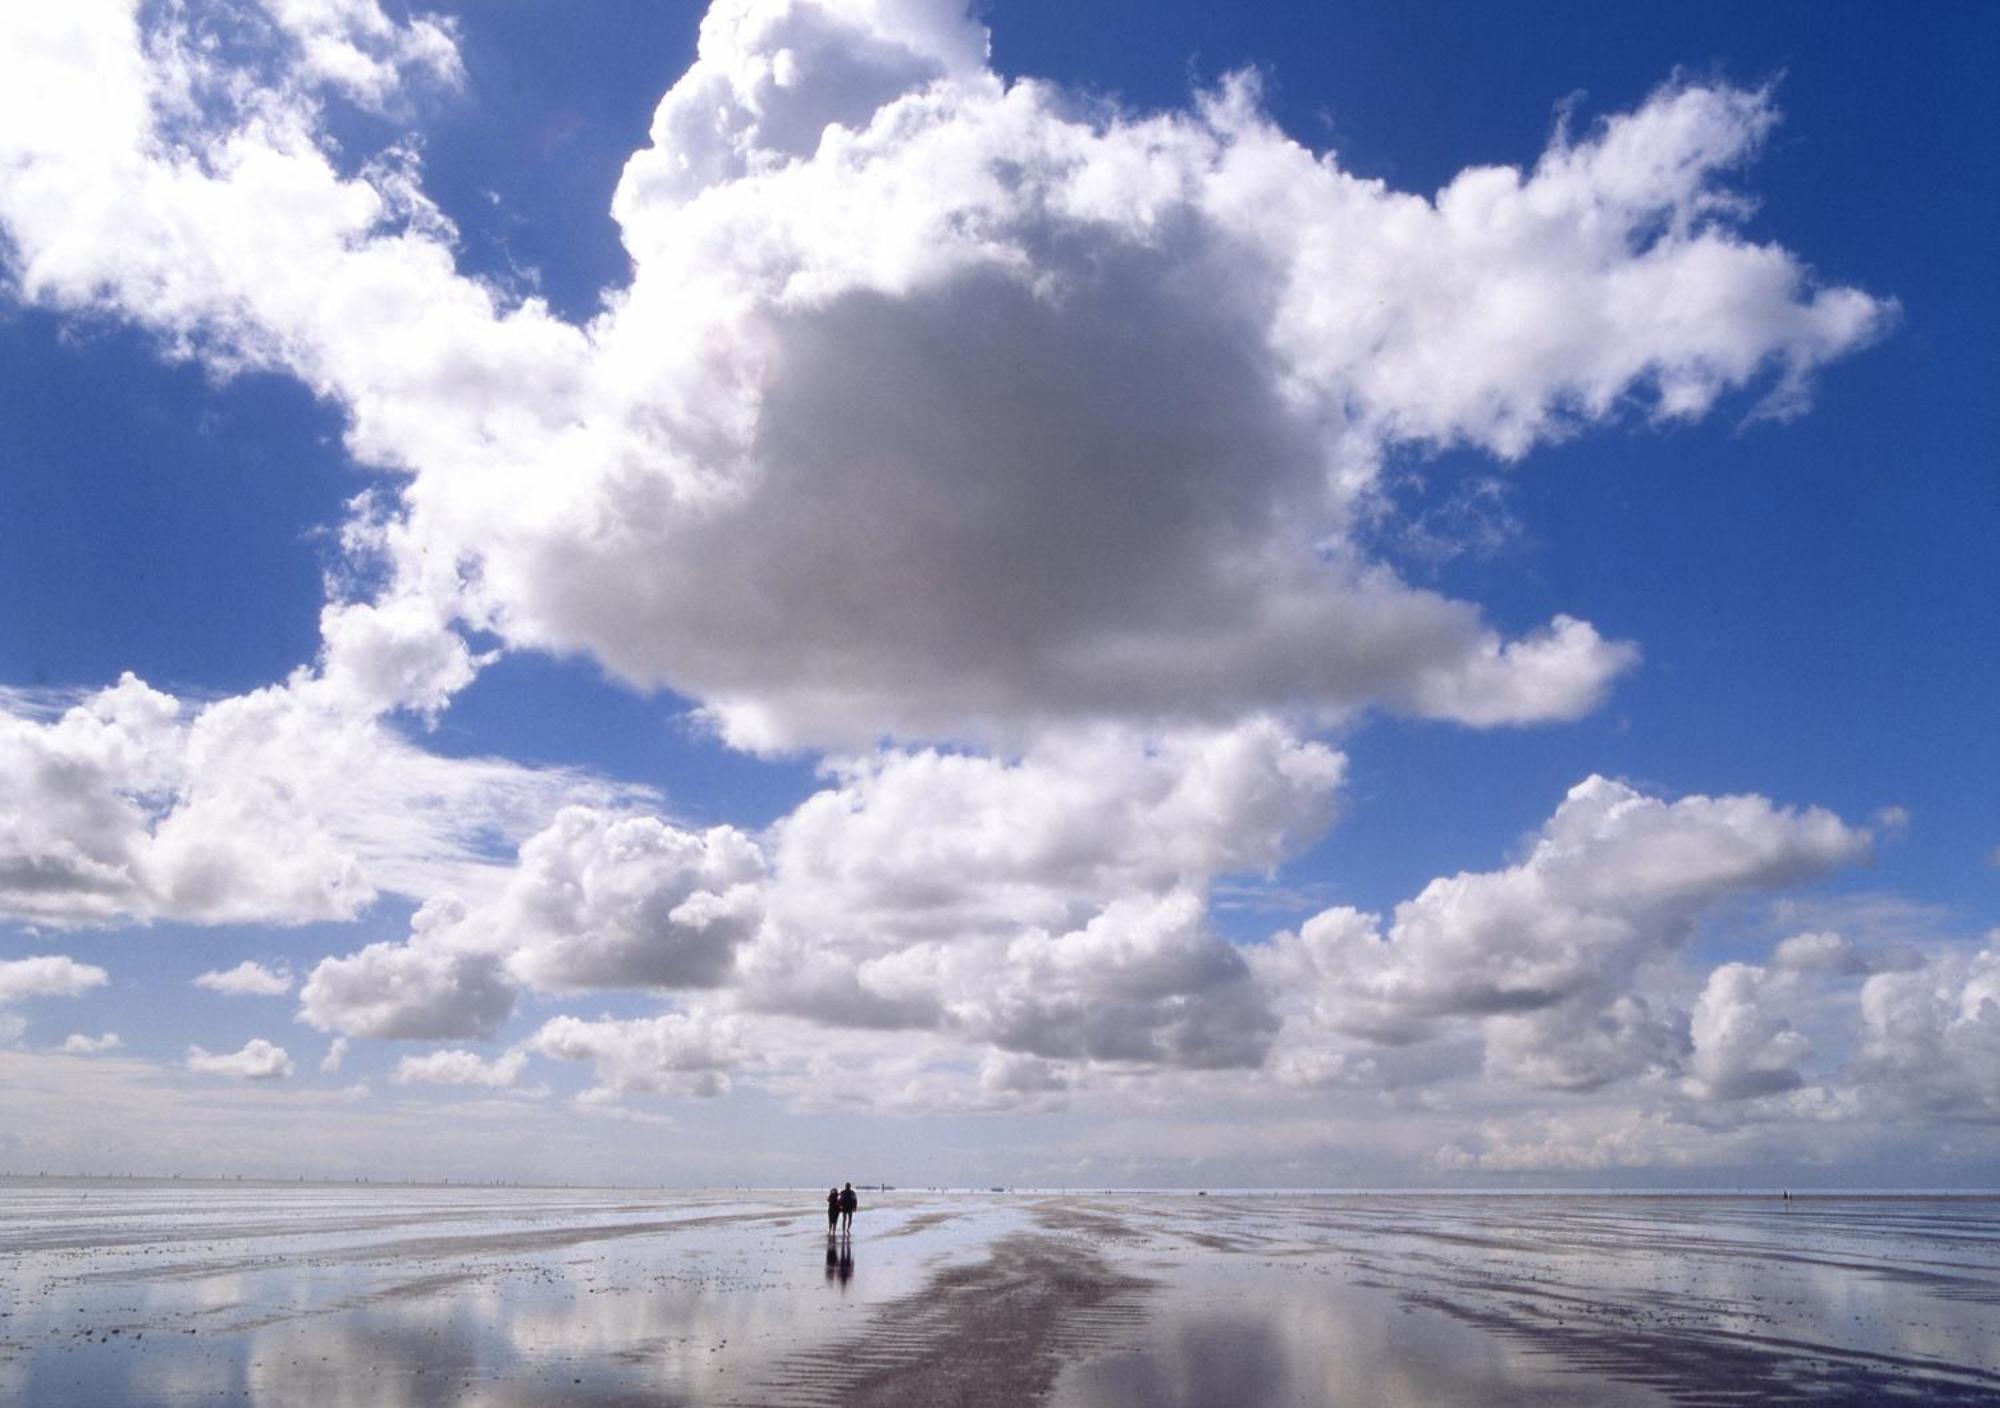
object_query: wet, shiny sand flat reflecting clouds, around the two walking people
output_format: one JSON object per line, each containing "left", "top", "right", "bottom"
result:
{"left": 0, "top": 1180, "right": 2000, "bottom": 1408}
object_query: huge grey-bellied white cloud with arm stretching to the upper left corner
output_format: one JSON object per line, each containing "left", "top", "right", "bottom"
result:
{"left": 0, "top": 0, "right": 1890, "bottom": 760}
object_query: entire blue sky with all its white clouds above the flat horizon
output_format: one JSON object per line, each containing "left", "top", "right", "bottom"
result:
{"left": 0, "top": 0, "right": 2000, "bottom": 1184}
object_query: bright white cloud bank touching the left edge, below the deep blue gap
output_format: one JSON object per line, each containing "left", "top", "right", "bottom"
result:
{"left": 0, "top": 672, "right": 632, "bottom": 924}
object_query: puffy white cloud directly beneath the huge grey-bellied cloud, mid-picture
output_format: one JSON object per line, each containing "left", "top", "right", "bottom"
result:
{"left": 740, "top": 720, "right": 1344, "bottom": 1066}
